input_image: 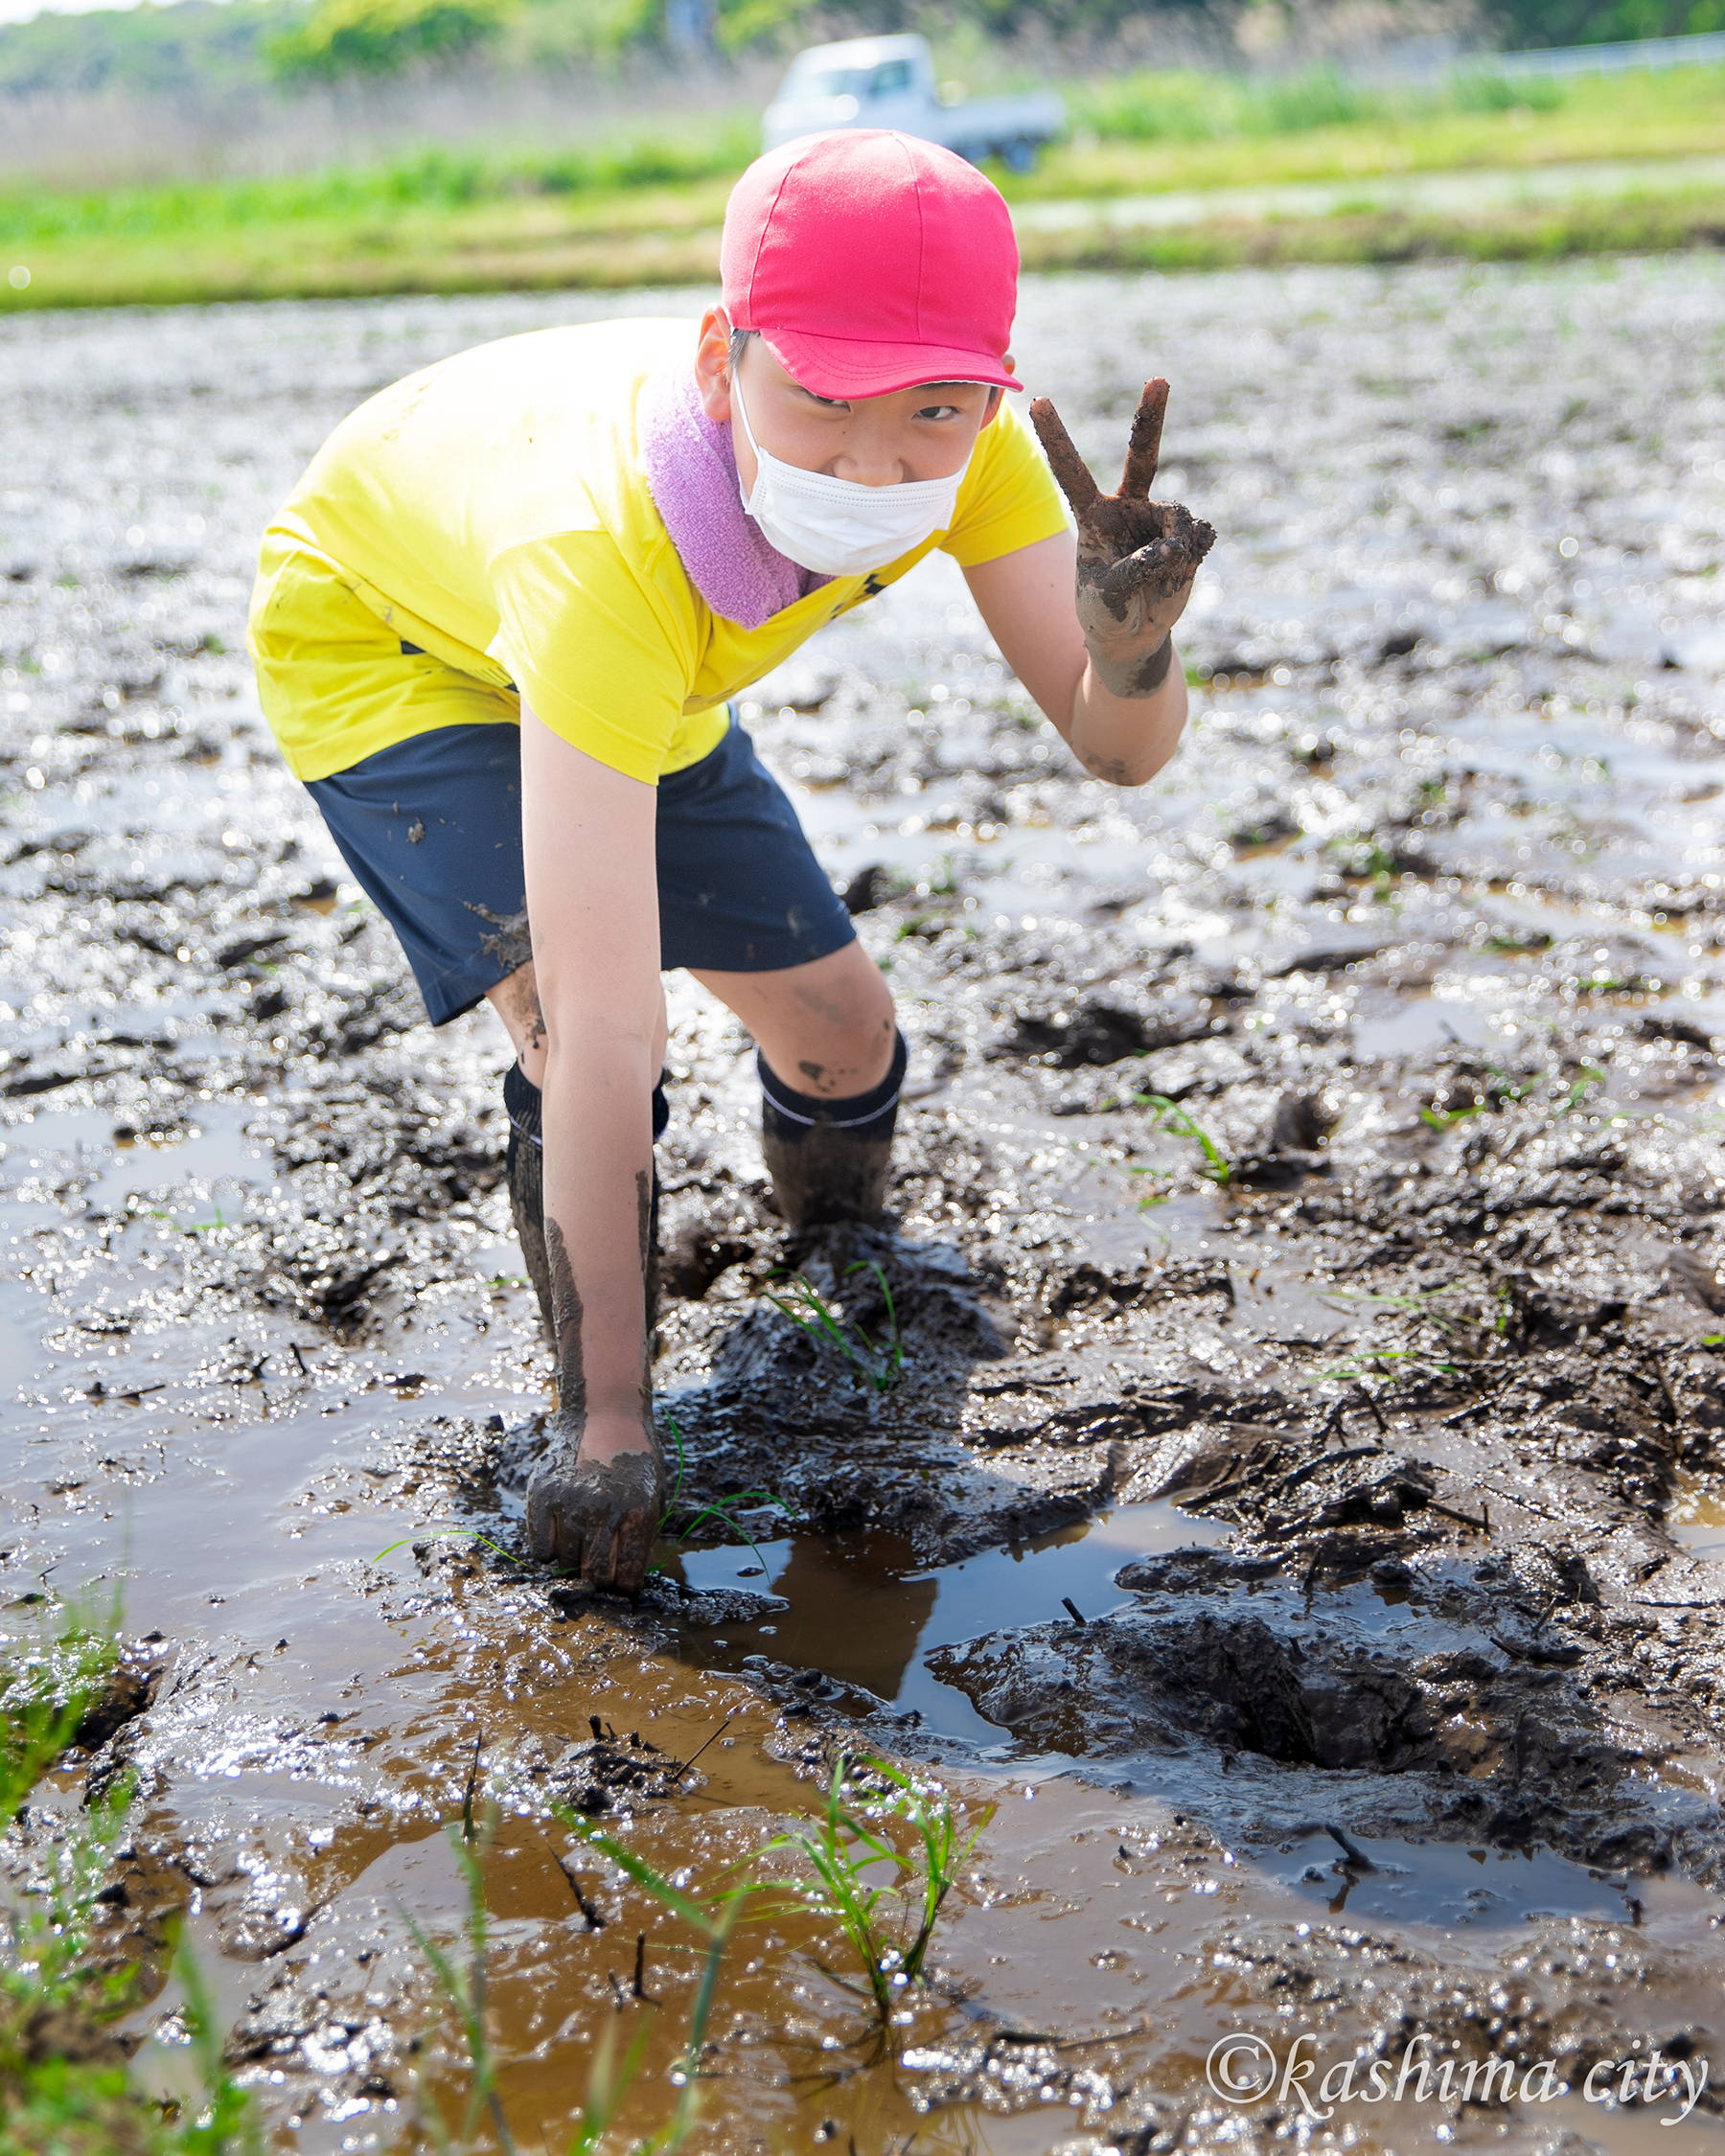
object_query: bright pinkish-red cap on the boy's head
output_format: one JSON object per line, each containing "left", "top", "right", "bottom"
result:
{"left": 721, "top": 127, "right": 1023, "bottom": 397}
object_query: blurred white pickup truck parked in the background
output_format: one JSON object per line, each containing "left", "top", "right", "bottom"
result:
{"left": 761, "top": 36, "right": 1066, "bottom": 172}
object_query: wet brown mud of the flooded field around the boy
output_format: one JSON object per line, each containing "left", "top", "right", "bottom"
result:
{"left": 0, "top": 261, "right": 1725, "bottom": 2156}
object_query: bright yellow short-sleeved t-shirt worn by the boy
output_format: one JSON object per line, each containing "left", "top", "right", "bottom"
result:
{"left": 252, "top": 321, "right": 1066, "bottom": 783}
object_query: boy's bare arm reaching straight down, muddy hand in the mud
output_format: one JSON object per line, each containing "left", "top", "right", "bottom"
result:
{"left": 522, "top": 705, "right": 664, "bottom": 1594}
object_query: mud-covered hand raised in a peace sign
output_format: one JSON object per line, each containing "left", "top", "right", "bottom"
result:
{"left": 1031, "top": 381, "right": 1216, "bottom": 697}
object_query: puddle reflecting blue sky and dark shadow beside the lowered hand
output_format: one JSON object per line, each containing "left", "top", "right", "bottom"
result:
{"left": 679, "top": 1505, "right": 1227, "bottom": 1757}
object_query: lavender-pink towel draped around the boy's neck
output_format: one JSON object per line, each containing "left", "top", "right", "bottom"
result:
{"left": 640, "top": 360, "right": 833, "bottom": 630}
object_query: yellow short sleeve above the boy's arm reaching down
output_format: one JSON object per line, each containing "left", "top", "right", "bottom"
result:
{"left": 492, "top": 531, "right": 699, "bottom": 785}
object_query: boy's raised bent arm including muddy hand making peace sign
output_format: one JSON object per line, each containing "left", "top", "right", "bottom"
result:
{"left": 966, "top": 381, "right": 1216, "bottom": 787}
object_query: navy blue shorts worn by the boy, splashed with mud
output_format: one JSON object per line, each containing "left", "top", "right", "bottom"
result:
{"left": 307, "top": 712, "right": 856, "bottom": 1026}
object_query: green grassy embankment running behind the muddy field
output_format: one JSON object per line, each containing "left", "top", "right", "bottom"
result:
{"left": 0, "top": 69, "right": 1725, "bottom": 310}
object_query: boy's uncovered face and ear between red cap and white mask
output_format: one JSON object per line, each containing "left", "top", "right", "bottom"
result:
{"left": 695, "top": 309, "right": 1011, "bottom": 493}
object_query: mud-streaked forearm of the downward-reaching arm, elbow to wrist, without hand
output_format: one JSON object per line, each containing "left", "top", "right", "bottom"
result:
{"left": 543, "top": 1040, "right": 654, "bottom": 1442}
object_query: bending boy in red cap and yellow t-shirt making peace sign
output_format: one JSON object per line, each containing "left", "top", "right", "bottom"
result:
{"left": 250, "top": 131, "right": 1214, "bottom": 1594}
